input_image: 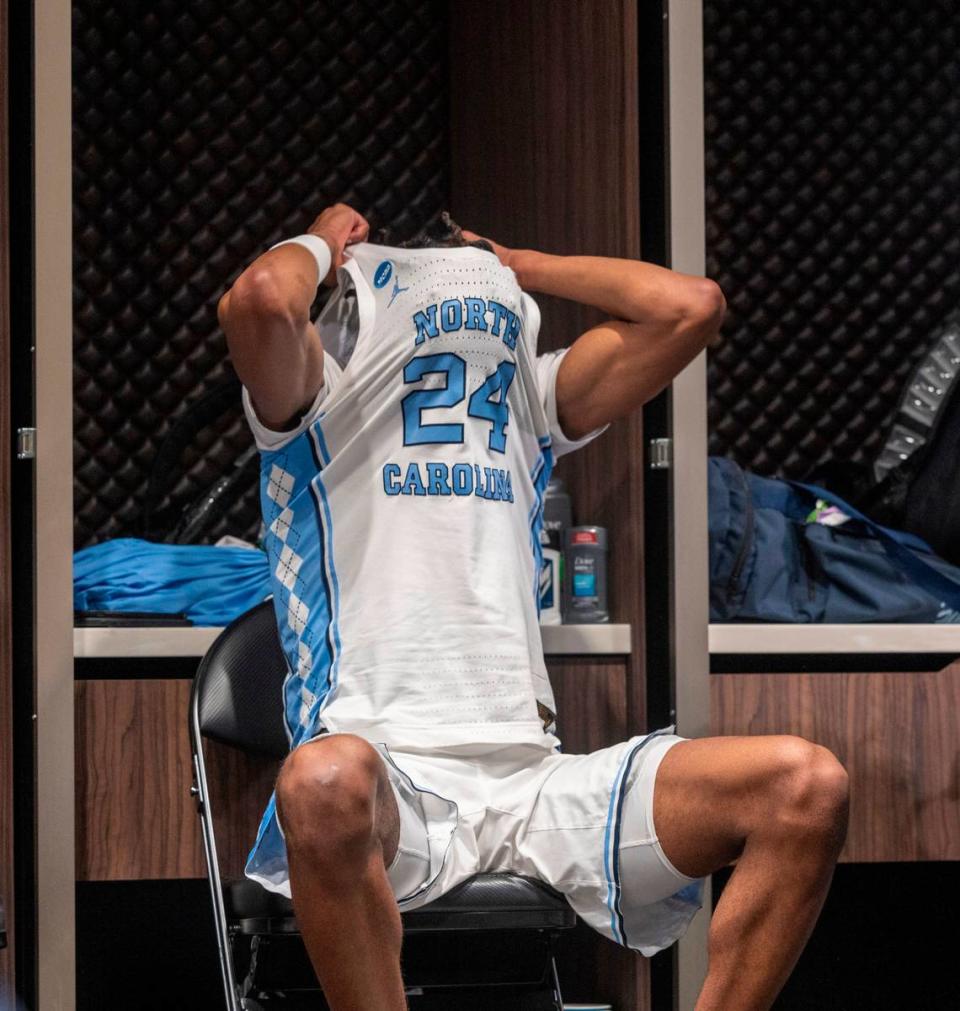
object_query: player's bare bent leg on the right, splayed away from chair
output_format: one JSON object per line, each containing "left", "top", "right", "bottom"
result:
{"left": 653, "top": 736, "right": 848, "bottom": 1011}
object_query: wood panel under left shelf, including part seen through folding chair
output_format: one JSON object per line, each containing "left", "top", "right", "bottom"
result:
{"left": 77, "top": 678, "right": 279, "bottom": 881}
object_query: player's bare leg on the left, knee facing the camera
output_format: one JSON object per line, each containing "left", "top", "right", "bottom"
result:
{"left": 277, "top": 734, "right": 406, "bottom": 1011}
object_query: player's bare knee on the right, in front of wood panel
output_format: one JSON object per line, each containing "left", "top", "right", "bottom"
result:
{"left": 770, "top": 737, "right": 850, "bottom": 845}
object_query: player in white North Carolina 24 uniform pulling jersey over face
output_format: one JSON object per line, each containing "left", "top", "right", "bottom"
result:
{"left": 218, "top": 204, "right": 847, "bottom": 1011}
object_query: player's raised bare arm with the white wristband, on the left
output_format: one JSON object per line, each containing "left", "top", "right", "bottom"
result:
{"left": 217, "top": 203, "right": 369, "bottom": 431}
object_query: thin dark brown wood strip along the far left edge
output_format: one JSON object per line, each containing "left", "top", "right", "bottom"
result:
{"left": 0, "top": 0, "right": 14, "bottom": 986}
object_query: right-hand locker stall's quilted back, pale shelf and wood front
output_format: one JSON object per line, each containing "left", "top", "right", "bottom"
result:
{"left": 704, "top": 0, "right": 960, "bottom": 861}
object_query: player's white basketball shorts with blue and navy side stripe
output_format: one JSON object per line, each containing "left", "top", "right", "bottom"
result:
{"left": 365, "top": 727, "right": 702, "bottom": 955}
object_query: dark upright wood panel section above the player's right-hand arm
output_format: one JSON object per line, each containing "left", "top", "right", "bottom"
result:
{"left": 450, "top": 0, "right": 640, "bottom": 264}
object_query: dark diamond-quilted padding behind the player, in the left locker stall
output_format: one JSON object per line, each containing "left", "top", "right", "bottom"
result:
{"left": 73, "top": 0, "right": 450, "bottom": 548}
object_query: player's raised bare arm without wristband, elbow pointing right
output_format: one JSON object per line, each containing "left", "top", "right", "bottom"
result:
{"left": 464, "top": 231, "right": 726, "bottom": 439}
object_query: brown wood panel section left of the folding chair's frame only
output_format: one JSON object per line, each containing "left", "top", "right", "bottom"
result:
{"left": 76, "top": 679, "right": 205, "bottom": 881}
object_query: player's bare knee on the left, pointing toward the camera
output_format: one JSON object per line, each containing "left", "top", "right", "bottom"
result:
{"left": 276, "top": 734, "right": 380, "bottom": 864}
